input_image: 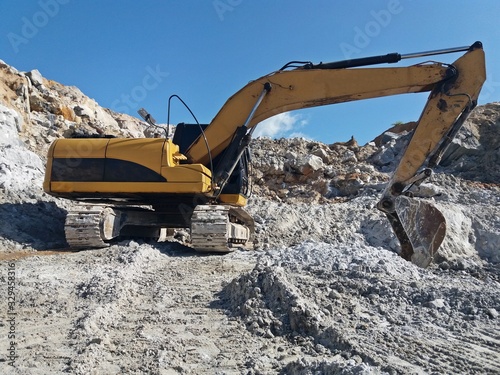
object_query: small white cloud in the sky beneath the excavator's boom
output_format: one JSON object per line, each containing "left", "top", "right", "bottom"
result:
{"left": 253, "top": 112, "right": 307, "bottom": 138}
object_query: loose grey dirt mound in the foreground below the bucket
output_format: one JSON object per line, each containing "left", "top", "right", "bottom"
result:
{"left": 221, "top": 242, "right": 500, "bottom": 373}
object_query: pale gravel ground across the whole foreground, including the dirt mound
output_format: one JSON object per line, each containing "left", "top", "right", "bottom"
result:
{"left": 0, "top": 241, "right": 500, "bottom": 374}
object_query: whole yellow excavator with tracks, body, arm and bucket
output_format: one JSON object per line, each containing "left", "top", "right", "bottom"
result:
{"left": 44, "top": 42, "right": 486, "bottom": 267}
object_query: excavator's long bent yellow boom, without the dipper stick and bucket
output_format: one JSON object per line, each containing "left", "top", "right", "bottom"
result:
{"left": 186, "top": 43, "right": 485, "bottom": 168}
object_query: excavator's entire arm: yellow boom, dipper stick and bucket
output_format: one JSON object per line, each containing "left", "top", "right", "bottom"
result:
{"left": 186, "top": 42, "right": 486, "bottom": 267}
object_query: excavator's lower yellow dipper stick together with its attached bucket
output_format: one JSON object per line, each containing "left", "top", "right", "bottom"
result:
{"left": 377, "top": 42, "right": 486, "bottom": 267}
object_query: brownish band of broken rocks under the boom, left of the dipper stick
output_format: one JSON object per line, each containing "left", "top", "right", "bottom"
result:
{"left": 252, "top": 138, "right": 387, "bottom": 203}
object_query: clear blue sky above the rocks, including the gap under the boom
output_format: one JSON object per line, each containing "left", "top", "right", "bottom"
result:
{"left": 0, "top": 0, "right": 500, "bottom": 144}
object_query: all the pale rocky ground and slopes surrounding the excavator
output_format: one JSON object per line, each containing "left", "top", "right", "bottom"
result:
{"left": 0, "top": 62, "right": 500, "bottom": 374}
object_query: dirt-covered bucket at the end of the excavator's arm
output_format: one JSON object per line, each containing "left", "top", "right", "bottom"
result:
{"left": 386, "top": 195, "right": 446, "bottom": 268}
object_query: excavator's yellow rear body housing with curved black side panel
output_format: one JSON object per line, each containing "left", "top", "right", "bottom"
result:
{"left": 44, "top": 138, "right": 211, "bottom": 198}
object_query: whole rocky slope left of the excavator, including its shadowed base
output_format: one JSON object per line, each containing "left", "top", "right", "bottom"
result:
{"left": 0, "top": 61, "right": 152, "bottom": 249}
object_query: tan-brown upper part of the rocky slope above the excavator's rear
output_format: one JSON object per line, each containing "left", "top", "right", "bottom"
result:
{"left": 0, "top": 61, "right": 146, "bottom": 157}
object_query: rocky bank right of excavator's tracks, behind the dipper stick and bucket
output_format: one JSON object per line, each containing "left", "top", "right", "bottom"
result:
{"left": 249, "top": 103, "right": 500, "bottom": 262}
